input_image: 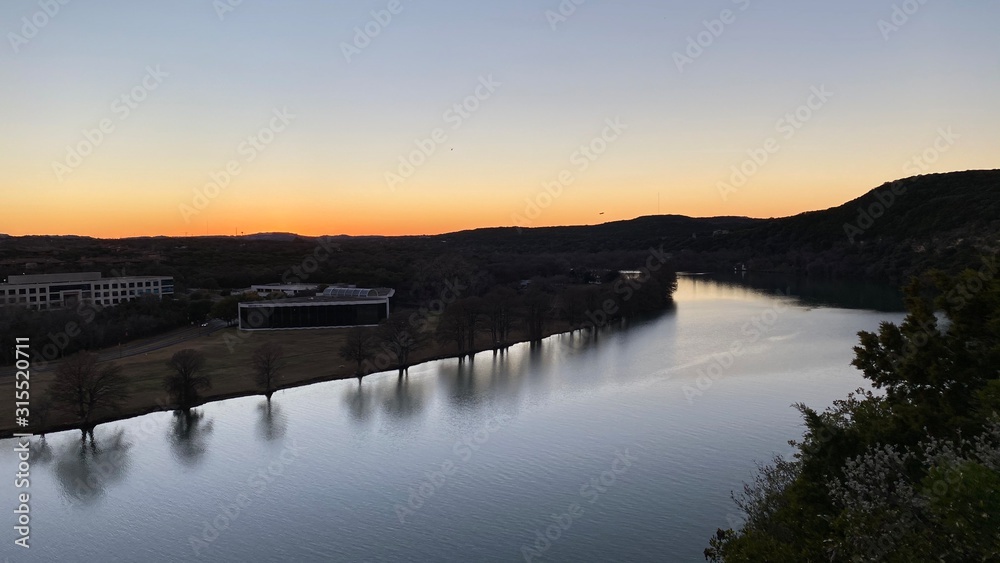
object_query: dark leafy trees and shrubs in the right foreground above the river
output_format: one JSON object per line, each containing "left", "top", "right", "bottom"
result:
{"left": 705, "top": 261, "right": 1000, "bottom": 563}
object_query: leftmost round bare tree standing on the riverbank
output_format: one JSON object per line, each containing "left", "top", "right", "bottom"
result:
{"left": 49, "top": 352, "right": 129, "bottom": 435}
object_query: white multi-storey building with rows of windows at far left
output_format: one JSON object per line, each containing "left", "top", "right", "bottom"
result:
{"left": 0, "top": 272, "right": 174, "bottom": 310}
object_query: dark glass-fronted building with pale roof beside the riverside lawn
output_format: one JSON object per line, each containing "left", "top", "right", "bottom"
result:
{"left": 240, "top": 287, "right": 395, "bottom": 331}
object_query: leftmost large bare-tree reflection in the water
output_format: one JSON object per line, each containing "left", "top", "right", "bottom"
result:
{"left": 55, "top": 429, "right": 132, "bottom": 504}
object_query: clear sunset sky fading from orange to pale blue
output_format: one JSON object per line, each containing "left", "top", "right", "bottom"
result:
{"left": 0, "top": 0, "right": 1000, "bottom": 238}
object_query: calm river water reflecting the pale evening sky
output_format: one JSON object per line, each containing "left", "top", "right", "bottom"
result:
{"left": 0, "top": 278, "right": 902, "bottom": 563}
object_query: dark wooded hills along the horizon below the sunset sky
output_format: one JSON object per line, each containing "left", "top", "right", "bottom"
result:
{"left": 0, "top": 170, "right": 1000, "bottom": 288}
